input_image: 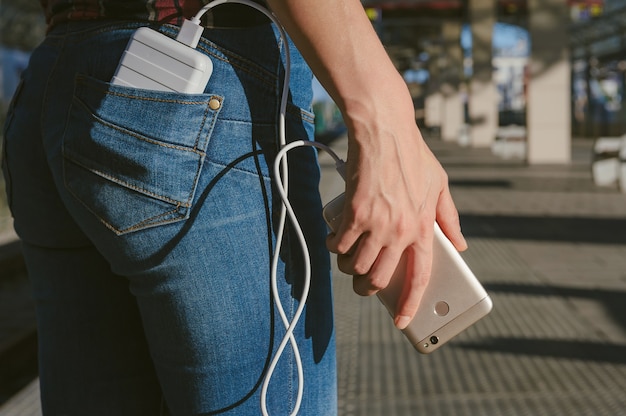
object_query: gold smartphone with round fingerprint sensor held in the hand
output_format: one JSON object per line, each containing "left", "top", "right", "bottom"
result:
{"left": 323, "top": 194, "right": 493, "bottom": 354}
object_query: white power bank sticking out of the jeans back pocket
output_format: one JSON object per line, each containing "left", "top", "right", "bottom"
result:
{"left": 111, "top": 27, "right": 213, "bottom": 94}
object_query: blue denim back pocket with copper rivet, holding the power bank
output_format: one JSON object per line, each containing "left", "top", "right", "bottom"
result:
{"left": 63, "top": 75, "right": 222, "bottom": 235}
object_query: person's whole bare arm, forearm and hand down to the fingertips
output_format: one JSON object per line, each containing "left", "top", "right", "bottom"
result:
{"left": 268, "top": 0, "right": 467, "bottom": 329}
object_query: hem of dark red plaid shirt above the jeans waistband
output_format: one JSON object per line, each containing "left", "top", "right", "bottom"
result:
{"left": 41, "top": 0, "right": 208, "bottom": 29}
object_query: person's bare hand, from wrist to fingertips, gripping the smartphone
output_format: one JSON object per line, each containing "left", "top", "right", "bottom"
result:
{"left": 327, "top": 75, "right": 467, "bottom": 329}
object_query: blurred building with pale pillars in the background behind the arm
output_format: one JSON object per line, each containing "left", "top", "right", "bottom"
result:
{"left": 363, "top": 0, "right": 626, "bottom": 163}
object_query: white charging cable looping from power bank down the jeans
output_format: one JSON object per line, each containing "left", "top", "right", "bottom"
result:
{"left": 176, "top": 0, "right": 343, "bottom": 416}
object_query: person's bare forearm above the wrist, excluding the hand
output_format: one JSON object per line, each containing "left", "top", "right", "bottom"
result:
{"left": 269, "top": 0, "right": 408, "bottom": 133}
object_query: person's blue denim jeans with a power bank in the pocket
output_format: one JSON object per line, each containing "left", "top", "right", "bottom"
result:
{"left": 3, "top": 22, "right": 336, "bottom": 416}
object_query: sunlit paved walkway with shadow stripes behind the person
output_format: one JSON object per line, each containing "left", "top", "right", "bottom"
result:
{"left": 0, "top": 140, "right": 626, "bottom": 416}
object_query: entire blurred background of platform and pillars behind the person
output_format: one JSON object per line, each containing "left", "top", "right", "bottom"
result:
{"left": 0, "top": 0, "right": 626, "bottom": 416}
